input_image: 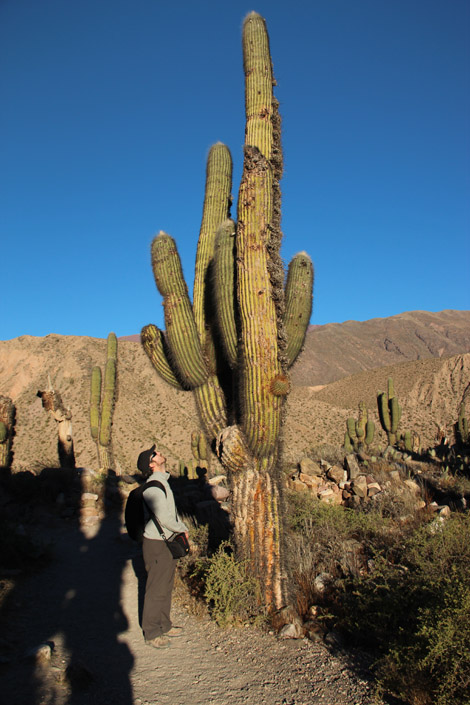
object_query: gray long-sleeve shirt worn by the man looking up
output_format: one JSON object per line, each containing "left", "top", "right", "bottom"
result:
{"left": 143, "top": 472, "right": 188, "bottom": 541}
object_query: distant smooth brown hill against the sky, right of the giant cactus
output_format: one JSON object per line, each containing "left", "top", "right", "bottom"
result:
{"left": 292, "top": 311, "right": 470, "bottom": 386}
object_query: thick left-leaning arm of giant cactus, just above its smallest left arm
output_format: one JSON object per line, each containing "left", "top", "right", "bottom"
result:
{"left": 152, "top": 232, "right": 208, "bottom": 388}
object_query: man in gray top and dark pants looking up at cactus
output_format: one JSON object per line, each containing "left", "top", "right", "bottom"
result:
{"left": 137, "top": 444, "right": 188, "bottom": 649}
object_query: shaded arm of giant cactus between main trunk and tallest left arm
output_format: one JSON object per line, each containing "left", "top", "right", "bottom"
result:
{"left": 213, "top": 220, "right": 238, "bottom": 369}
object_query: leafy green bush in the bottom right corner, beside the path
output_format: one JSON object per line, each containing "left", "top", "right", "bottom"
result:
{"left": 342, "top": 514, "right": 470, "bottom": 705}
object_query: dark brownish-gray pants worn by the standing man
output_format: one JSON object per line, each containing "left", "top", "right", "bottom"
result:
{"left": 142, "top": 538, "right": 176, "bottom": 640}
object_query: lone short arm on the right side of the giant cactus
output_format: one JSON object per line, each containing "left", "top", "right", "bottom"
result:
{"left": 284, "top": 252, "right": 314, "bottom": 367}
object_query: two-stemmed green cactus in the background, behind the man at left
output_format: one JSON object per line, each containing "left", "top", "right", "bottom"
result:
{"left": 90, "top": 333, "right": 117, "bottom": 469}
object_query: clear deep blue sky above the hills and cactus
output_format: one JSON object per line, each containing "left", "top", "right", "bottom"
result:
{"left": 0, "top": 0, "right": 470, "bottom": 339}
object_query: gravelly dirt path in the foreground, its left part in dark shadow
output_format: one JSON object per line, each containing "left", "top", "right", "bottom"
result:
{"left": 0, "top": 517, "right": 386, "bottom": 705}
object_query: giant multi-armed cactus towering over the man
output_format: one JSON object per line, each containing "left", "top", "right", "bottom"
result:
{"left": 142, "top": 12, "right": 313, "bottom": 609}
